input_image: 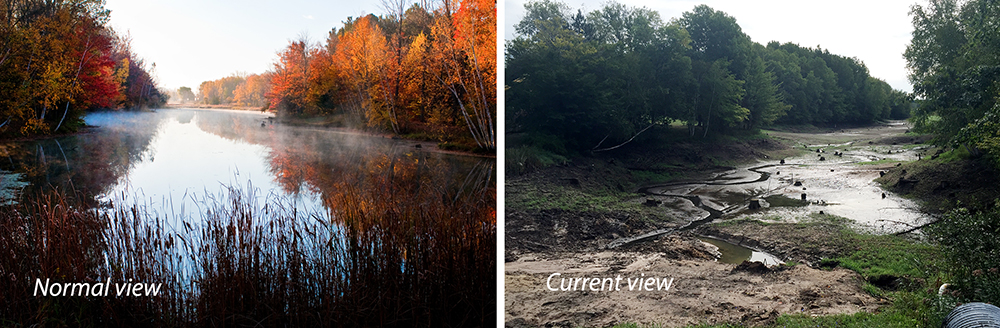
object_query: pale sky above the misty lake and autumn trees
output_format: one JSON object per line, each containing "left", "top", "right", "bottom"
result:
{"left": 105, "top": 0, "right": 383, "bottom": 92}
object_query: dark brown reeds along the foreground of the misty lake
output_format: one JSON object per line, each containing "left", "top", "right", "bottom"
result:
{"left": 0, "top": 167, "right": 496, "bottom": 327}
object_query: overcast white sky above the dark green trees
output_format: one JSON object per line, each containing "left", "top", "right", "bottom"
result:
{"left": 503, "top": 0, "right": 926, "bottom": 92}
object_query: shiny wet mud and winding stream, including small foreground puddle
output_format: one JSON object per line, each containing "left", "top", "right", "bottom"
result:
{"left": 605, "top": 145, "right": 927, "bottom": 265}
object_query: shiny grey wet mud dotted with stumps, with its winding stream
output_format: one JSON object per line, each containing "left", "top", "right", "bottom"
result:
{"left": 608, "top": 122, "right": 929, "bottom": 256}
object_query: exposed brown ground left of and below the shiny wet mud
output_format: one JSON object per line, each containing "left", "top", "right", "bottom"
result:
{"left": 504, "top": 123, "right": 926, "bottom": 327}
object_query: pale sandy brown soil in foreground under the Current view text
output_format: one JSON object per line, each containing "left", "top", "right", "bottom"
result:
{"left": 504, "top": 234, "right": 880, "bottom": 327}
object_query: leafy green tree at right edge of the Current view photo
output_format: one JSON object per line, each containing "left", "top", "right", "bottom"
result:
{"left": 904, "top": 0, "right": 1000, "bottom": 155}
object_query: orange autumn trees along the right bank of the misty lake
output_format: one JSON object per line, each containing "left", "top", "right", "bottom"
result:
{"left": 190, "top": 0, "right": 497, "bottom": 150}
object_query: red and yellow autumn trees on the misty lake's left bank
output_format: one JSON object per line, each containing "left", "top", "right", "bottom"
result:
{"left": 0, "top": 0, "right": 166, "bottom": 137}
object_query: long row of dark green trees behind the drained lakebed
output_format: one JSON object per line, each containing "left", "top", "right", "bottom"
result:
{"left": 504, "top": 0, "right": 912, "bottom": 153}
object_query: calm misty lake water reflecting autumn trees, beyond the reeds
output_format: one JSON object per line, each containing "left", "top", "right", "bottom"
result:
{"left": 0, "top": 109, "right": 496, "bottom": 218}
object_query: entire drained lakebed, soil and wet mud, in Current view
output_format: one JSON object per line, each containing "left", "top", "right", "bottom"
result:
{"left": 505, "top": 122, "right": 941, "bottom": 327}
